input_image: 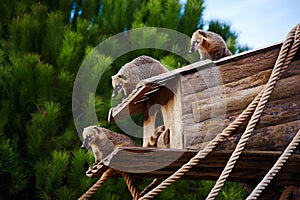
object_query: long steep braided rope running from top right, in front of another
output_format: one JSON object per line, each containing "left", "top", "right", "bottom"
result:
{"left": 206, "top": 25, "right": 299, "bottom": 200}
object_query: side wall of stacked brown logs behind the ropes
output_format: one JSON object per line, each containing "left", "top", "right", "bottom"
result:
{"left": 181, "top": 45, "right": 300, "bottom": 150}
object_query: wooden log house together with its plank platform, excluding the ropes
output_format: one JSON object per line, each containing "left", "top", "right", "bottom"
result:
{"left": 86, "top": 36, "right": 300, "bottom": 199}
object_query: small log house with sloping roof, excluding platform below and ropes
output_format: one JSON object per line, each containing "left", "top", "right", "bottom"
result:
{"left": 110, "top": 43, "right": 300, "bottom": 150}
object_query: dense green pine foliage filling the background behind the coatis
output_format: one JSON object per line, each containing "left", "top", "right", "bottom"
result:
{"left": 0, "top": 0, "right": 247, "bottom": 200}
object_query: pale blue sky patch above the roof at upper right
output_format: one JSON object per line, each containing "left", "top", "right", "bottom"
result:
{"left": 203, "top": 0, "right": 300, "bottom": 48}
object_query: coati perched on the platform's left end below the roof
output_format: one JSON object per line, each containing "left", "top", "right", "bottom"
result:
{"left": 81, "top": 126, "right": 137, "bottom": 163}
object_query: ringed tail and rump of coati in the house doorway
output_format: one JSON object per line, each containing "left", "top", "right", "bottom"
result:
{"left": 146, "top": 125, "right": 170, "bottom": 148}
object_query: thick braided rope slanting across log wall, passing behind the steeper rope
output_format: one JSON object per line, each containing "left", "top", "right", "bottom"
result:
{"left": 140, "top": 81, "right": 262, "bottom": 199}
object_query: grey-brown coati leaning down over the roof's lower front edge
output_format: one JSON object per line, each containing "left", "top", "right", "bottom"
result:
{"left": 111, "top": 55, "right": 169, "bottom": 98}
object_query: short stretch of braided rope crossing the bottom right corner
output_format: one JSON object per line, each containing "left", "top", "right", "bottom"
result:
{"left": 247, "top": 129, "right": 300, "bottom": 200}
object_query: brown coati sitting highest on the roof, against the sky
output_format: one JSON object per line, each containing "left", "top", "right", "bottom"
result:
{"left": 189, "top": 29, "right": 232, "bottom": 60}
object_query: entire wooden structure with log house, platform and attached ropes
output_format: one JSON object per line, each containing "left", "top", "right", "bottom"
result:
{"left": 81, "top": 24, "right": 300, "bottom": 199}
